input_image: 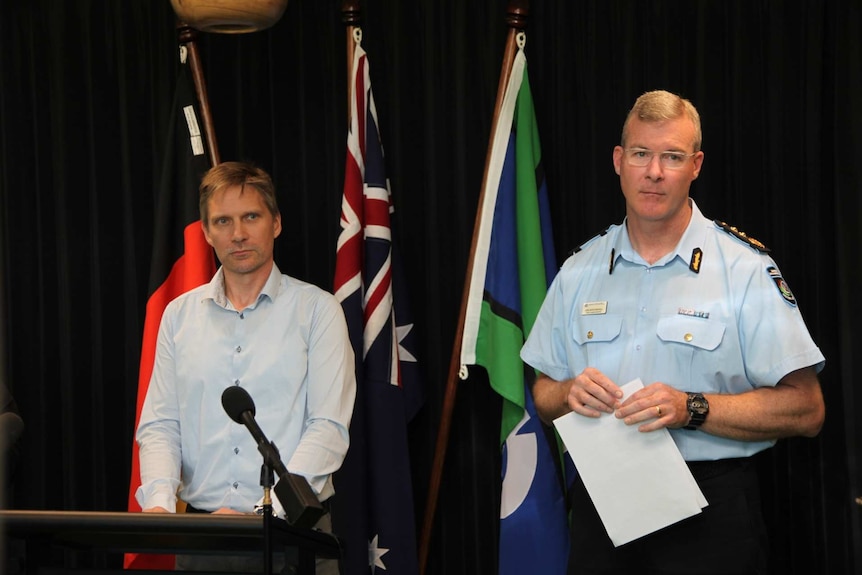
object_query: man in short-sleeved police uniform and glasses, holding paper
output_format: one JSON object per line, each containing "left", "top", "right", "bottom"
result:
{"left": 521, "top": 91, "right": 825, "bottom": 574}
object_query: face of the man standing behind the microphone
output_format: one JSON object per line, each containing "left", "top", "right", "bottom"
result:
{"left": 203, "top": 186, "right": 281, "bottom": 274}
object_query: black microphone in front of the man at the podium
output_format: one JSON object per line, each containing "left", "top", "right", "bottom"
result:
{"left": 221, "top": 385, "right": 324, "bottom": 529}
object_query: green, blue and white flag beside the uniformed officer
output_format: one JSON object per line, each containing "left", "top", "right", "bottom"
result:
{"left": 461, "top": 49, "right": 569, "bottom": 575}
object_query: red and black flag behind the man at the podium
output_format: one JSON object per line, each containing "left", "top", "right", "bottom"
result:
{"left": 125, "top": 46, "right": 215, "bottom": 570}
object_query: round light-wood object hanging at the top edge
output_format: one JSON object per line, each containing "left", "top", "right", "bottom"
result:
{"left": 171, "top": 0, "right": 288, "bottom": 34}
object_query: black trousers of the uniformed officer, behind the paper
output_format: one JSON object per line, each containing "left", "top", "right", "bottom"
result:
{"left": 568, "top": 458, "right": 769, "bottom": 575}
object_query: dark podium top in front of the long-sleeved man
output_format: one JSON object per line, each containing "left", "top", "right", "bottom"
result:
{"left": 0, "top": 510, "right": 341, "bottom": 575}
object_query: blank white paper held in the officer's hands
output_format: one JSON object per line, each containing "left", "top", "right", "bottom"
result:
{"left": 554, "top": 379, "right": 708, "bottom": 547}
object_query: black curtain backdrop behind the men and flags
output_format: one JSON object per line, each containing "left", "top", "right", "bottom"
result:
{"left": 0, "top": 0, "right": 862, "bottom": 575}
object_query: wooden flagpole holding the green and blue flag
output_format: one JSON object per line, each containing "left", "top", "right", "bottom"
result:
{"left": 419, "top": 0, "right": 530, "bottom": 575}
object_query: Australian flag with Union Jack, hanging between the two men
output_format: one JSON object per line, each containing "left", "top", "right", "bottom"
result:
{"left": 332, "top": 43, "right": 422, "bottom": 575}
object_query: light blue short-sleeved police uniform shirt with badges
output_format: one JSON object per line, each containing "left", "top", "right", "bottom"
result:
{"left": 521, "top": 200, "right": 825, "bottom": 461}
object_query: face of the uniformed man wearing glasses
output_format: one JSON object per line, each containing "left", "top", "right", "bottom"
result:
{"left": 614, "top": 116, "right": 703, "bottom": 222}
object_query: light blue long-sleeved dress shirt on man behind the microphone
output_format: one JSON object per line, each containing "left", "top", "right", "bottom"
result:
{"left": 136, "top": 265, "right": 356, "bottom": 515}
